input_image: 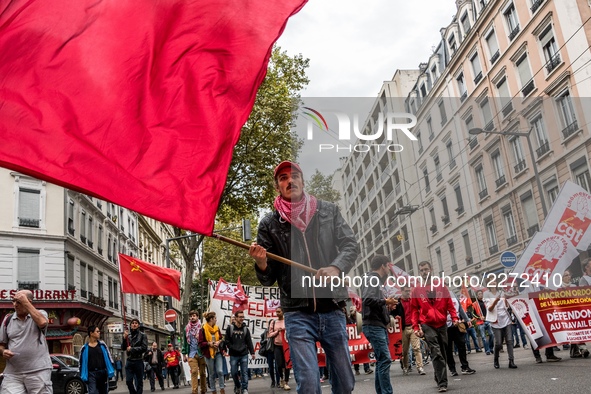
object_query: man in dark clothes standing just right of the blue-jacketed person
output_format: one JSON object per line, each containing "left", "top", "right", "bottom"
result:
{"left": 121, "top": 318, "right": 148, "bottom": 394}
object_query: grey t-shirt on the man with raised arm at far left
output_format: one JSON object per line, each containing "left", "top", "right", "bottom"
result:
{"left": 0, "top": 310, "right": 52, "bottom": 374}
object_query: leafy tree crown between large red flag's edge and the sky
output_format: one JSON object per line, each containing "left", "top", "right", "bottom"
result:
{"left": 218, "top": 47, "right": 308, "bottom": 222}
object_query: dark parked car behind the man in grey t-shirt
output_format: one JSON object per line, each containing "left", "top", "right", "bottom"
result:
{"left": 51, "top": 354, "right": 117, "bottom": 394}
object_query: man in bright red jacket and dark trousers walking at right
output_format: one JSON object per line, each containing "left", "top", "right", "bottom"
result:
{"left": 410, "top": 261, "right": 458, "bottom": 392}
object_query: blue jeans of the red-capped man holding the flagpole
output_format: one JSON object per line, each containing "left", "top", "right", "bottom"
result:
{"left": 285, "top": 310, "right": 355, "bottom": 394}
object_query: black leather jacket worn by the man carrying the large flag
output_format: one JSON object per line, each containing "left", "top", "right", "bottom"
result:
{"left": 255, "top": 200, "right": 359, "bottom": 312}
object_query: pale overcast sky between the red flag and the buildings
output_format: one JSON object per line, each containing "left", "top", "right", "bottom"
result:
{"left": 278, "top": 0, "right": 456, "bottom": 178}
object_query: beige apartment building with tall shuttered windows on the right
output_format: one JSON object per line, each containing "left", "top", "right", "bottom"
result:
{"left": 344, "top": 0, "right": 591, "bottom": 275}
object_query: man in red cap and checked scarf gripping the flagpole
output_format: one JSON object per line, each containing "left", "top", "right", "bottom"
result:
{"left": 249, "top": 161, "right": 359, "bottom": 394}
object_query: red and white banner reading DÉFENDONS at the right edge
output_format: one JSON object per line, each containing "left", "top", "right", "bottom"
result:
{"left": 509, "top": 286, "right": 591, "bottom": 348}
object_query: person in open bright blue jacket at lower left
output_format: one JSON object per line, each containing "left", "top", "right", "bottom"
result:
{"left": 80, "top": 325, "right": 115, "bottom": 394}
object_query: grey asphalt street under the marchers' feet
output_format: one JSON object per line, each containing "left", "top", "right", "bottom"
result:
{"left": 113, "top": 348, "right": 591, "bottom": 394}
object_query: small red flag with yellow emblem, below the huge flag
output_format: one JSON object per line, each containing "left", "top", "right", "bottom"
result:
{"left": 119, "top": 253, "right": 181, "bottom": 300}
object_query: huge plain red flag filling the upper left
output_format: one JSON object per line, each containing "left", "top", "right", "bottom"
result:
{"left": 0, "top": 0, "right": 306, "bottom": 235}
